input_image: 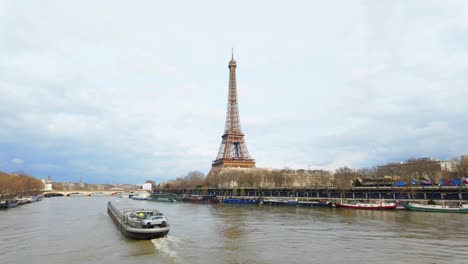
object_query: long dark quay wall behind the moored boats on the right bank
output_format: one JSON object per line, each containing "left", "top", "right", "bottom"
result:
{"left": 177, "top": 186, "right": 468, "bottom": 201}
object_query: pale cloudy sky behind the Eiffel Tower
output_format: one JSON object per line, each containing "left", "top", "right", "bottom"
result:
{"left": 0, "top": 0, "right": 468, "bottom": 183}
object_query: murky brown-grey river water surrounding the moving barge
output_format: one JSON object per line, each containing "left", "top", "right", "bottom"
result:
{"left": 0, "top": 197, "right": 468, "bottom": 264}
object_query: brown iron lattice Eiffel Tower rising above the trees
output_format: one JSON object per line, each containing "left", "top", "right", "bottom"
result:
{"left": 209, "top": 53, "right": 255, "bottom": 174}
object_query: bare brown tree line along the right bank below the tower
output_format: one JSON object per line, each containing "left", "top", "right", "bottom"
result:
{"left": 157, "top": 160, "right": 468, "bottom": 190}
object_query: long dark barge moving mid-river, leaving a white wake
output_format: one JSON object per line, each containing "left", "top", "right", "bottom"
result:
{"left": 107, "top": 202, "right": 169, "bottom": 240}
